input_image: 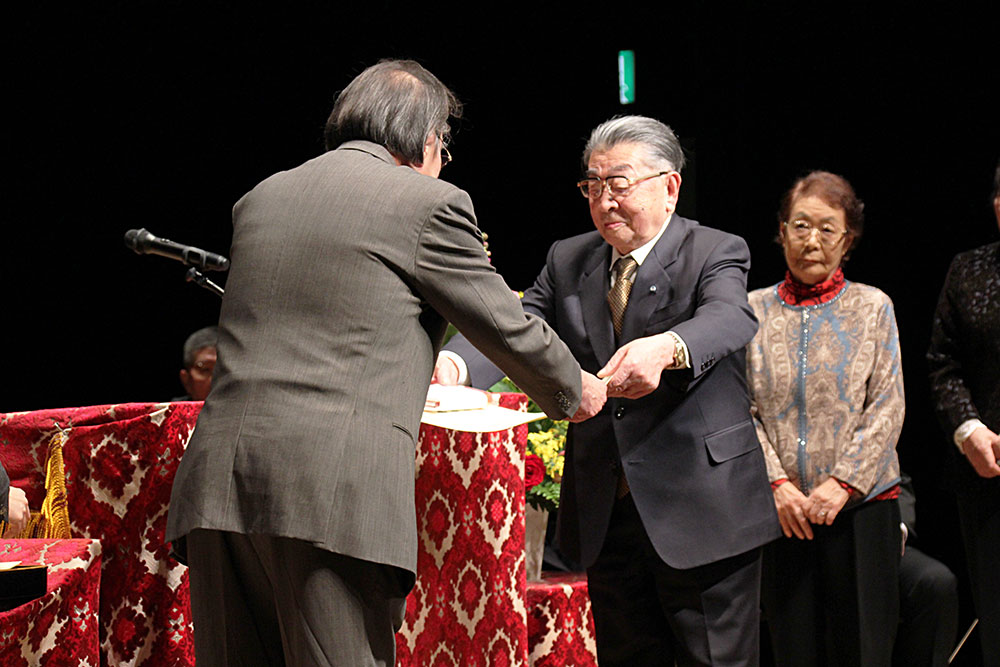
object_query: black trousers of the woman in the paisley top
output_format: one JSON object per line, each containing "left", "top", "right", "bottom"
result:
{"left": 761, "top": 500, "right": 902, "bottom": 667}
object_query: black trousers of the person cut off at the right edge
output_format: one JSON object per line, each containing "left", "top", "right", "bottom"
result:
{"left": 958, "top": 475, "right": 1000, "bottom": 667}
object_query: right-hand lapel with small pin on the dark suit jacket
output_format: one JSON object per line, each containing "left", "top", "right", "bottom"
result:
{"left": 622, "top": 215, "right": 691, "bottom": 342}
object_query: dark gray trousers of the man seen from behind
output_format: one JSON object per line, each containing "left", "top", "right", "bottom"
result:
{"left": 187, "top": 530, "right": 406, "bottom": 667}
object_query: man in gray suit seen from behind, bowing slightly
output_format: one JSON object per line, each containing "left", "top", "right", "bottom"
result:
{"left": 166, "top": 61, "right": 605, "bottom": 667}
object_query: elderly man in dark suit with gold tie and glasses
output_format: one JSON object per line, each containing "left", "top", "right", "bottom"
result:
{"left": 435, "top": 116, "right": 780, "bottom": 667}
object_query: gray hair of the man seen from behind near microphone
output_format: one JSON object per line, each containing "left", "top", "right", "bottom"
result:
{"left": 324, "top": 60, "right": 462, "bottom": 164}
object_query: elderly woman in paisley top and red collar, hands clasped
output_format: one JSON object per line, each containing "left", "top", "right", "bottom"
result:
{"left": 747, "top": 171, "right": 904, "bottom": 666}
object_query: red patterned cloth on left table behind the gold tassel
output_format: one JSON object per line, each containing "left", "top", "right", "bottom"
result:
{"left": 0, "top": 403, "right": 201, "bottom": 666}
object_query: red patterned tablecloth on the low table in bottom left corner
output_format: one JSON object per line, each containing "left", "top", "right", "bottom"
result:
{"left": 0, "top": 540, "right": 101, "bottom": 667}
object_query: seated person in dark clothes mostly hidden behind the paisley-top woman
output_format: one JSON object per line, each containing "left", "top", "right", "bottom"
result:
{"left": 892, "top": 475, "right": 958, "bottom": 667}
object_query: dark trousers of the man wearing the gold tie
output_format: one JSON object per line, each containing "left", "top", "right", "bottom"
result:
{"left": 587, "top": 495, "right": 760, "bottom": 667}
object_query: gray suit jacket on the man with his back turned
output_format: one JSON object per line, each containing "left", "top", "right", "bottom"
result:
{"left": 166, "top": 141, "right": 580, "bottom": 583}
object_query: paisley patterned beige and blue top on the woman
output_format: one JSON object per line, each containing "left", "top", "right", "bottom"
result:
{"left": 747, "top": 271, "right": 905, "bottom": 500}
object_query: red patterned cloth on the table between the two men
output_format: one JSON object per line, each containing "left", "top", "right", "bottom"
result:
{"left": 396, "top": 394, "right": 528, "bottom": 667}
